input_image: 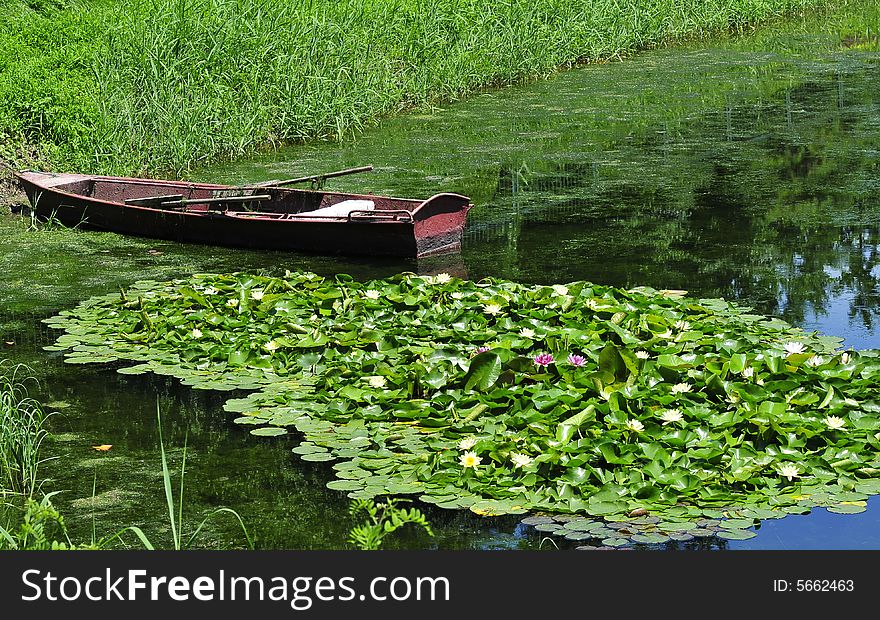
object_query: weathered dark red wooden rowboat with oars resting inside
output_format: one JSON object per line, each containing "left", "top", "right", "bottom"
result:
{"left": 16, "top": 170, "right": 473, "bottom": 258}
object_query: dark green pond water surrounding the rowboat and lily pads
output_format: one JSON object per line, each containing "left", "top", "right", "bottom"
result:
{"left": 0, "top": 4, "right": 880, "bottom": 549}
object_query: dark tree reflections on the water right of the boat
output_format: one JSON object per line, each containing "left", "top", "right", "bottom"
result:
{"left": 469, "top": 62, "right": 880, "bottom": 336}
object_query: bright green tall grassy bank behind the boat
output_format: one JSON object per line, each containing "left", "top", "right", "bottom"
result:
{"left": 0, "top": 0, "right": 839, "bottom": 184}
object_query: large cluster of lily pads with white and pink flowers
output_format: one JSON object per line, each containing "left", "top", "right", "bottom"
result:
{"left": 48, "top": 272, "right": 880, "bottom": 545}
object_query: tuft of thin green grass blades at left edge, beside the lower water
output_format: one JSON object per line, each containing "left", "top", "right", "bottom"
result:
{"left": 0, "top": 360, "right": 48, "bottom": 498}
